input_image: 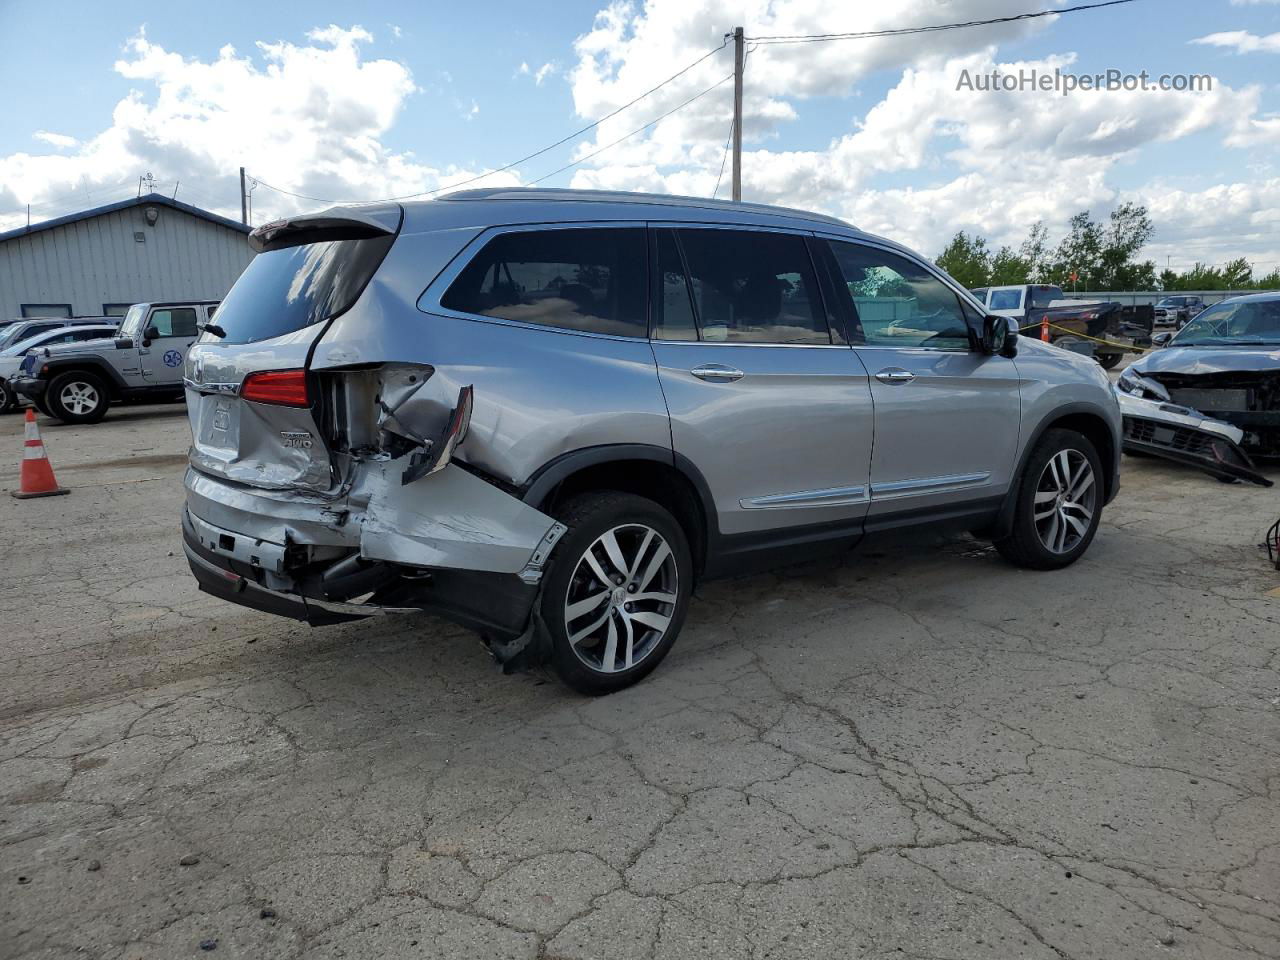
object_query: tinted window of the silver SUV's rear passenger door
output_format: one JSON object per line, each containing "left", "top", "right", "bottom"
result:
{"left": 677, "top": 229, "right": 831, "bottom": 343}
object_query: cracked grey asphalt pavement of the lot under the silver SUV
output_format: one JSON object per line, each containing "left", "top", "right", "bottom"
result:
{"left": 0, "top": 404, "right": 1280, "bottom": 960}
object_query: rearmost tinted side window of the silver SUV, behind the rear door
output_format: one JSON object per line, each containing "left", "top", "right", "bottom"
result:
{"left": 440, "top": 228, "right": 648, "bottom": 337}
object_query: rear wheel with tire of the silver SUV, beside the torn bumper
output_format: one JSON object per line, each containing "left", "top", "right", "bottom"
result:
{"left": 541, "top": 492, "right": 694, "bottom": 695}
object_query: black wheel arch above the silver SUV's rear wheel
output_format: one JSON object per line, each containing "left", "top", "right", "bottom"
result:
{"left": 521, "top": 443, "right": 718, "bottom": 576}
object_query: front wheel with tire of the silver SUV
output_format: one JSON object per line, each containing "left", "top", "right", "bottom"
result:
{"left": 996, "top": 429, "right": 1103, "bottom": 570}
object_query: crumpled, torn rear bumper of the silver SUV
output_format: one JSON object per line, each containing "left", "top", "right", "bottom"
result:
{"left": 183, "top": 460, "right": 564, "bottom": 637}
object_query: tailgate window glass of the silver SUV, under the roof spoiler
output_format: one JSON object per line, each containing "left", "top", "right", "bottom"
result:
{"left": 208, "top": 236, "right": 396, "bottom": 343}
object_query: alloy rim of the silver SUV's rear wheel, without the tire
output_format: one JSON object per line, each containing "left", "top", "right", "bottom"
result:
{"left": 564, "top": 524, "right": 680, "bottom": 673}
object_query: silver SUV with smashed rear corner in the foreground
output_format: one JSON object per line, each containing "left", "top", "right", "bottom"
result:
{"left": 183, "top": 189, "right": 1120, "bottom": 692}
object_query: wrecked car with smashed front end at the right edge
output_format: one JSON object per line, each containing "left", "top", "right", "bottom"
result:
{"left": 1116, "top": 293, "right": 1280, "bottom": 486}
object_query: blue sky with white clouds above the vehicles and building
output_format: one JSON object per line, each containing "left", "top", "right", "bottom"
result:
{"left": 0, "top": 0, "right": 1280, "bottom": 274}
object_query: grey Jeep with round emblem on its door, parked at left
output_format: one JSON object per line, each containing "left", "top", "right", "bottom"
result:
{"left": 10, "top": 301, "right": 218, "bottom": 424}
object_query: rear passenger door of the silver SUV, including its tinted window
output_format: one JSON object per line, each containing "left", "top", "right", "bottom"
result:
{"left": 650, "top": 224, "right": 872, "bottom": 547}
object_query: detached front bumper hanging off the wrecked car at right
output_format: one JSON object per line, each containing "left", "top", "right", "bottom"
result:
{"left": 1116, "top": 389, "right": 1271, "bottom": 486}
